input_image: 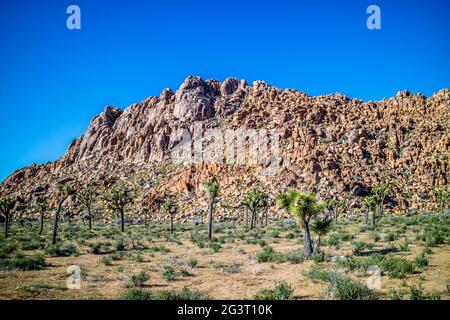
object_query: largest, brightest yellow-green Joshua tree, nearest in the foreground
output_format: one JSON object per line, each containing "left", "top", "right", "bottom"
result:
{"left": 277, "top": 190, "right": 325, "bottom": 259}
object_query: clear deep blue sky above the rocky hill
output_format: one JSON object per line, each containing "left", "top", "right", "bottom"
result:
{"left": 0, "top": 0, "right": 450, "bottom": 181}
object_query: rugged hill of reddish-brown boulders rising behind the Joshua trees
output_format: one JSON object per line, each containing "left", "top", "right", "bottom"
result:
{"left": 0, "top": 77, "right": 450, "bottom": 220}
